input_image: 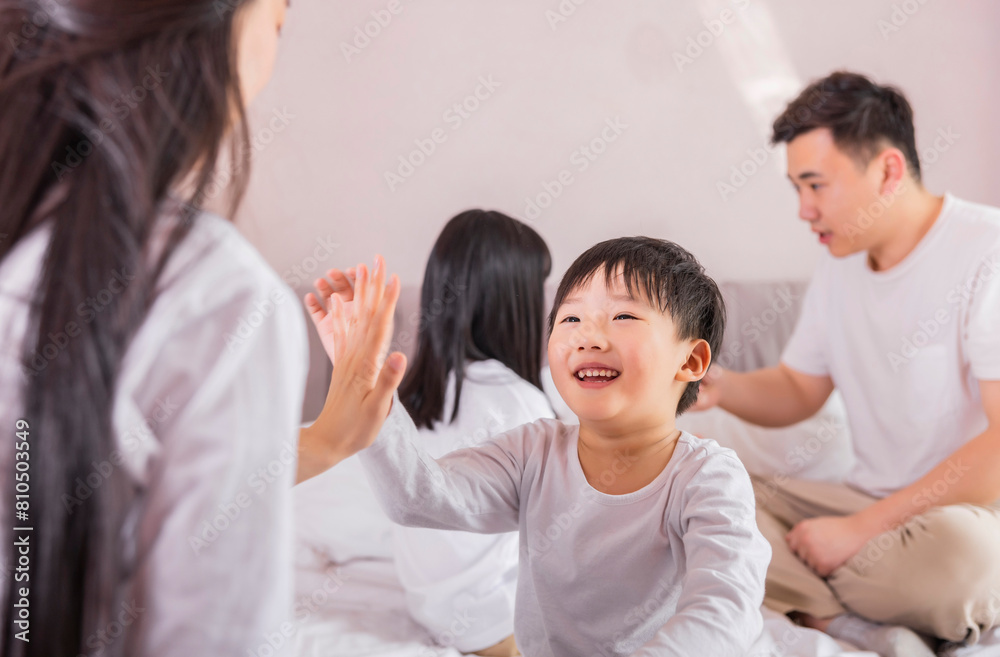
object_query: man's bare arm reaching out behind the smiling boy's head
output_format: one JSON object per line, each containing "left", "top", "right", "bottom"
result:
{"left": 695, "top": 363, "right": 833, "bottom": 427}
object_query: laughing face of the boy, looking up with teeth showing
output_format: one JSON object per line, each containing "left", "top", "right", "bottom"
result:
{"left": 548, "top": 270, "right": 703, "bottom": 433}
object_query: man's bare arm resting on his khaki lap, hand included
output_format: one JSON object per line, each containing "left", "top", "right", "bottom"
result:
{"left": 786, "top": 381, "right": 1000, "bottom": 577}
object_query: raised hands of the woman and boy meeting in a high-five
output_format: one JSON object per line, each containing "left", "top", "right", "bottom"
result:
{"left": 297, "top": 256, "right": 406, "bottom": 482}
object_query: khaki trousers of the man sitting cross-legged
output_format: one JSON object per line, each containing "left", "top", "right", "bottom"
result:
{"left": 752, "top": 476, "right": 1000, "bottom": 644}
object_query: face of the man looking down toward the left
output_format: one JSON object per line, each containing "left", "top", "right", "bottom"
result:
{"left": 788, "top": 128, "right": 884, "bottom": 258}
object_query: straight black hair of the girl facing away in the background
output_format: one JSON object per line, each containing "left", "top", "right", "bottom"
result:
{"left": 399, "top": 210, "right": 552, "bottom": 429}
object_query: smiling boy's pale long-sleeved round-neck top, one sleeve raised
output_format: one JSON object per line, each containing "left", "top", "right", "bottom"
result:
{"left": 360, "top": 399, "right": 771, "bottom": 657}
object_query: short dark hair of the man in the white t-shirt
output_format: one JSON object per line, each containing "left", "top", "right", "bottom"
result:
{"left": 771, "top": 71, "right": 920, "bottom": 182}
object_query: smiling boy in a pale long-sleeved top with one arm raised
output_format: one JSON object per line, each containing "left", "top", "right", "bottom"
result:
{"left": 334, "top": 237, "right": 770, "bottom": 657}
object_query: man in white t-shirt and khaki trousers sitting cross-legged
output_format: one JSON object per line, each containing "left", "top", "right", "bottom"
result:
{"left": 698, "top": 72, "right": 1000, "bottom": 657}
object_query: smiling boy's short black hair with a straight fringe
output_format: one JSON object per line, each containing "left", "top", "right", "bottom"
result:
{"left": 549, "top": 237, "right": 726, "bottom": 415}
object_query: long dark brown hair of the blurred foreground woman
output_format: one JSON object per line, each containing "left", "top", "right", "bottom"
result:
{"left": 0, "top": 0, "right": 250, "bottom": 656}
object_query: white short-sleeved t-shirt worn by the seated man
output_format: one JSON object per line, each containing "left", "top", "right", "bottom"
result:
{"left": 782, "top": 195, "right": 1000, "bottom": 497}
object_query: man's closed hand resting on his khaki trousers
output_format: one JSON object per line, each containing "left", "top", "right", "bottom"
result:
{"left": 785, "top": 516, "right": 879, "bottom": 577}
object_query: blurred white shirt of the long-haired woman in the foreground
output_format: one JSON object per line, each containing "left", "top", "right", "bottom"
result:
{"left": 0, "top": 214, "right": 308, "bottom": 656}
